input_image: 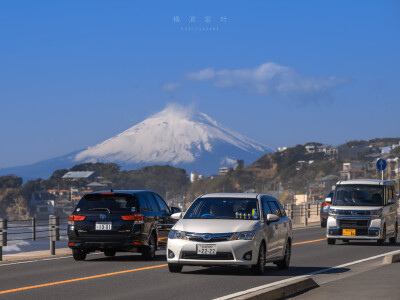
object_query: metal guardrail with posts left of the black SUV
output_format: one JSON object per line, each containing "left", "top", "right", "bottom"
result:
{"left": 0, "top": 215, "right": 67, "bottom": 261}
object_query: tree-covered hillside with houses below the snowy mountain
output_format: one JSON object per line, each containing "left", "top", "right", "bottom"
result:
{"left": 0, "top": 138, "right": 400, "bottom": 219}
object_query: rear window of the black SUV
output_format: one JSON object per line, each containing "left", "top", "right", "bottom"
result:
{"left": 76, "top": 194, "right": 137, "bottom": 212}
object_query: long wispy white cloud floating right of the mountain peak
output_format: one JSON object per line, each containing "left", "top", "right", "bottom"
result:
{"left": 187, "top": 62, "right": 346, "bottom": 97}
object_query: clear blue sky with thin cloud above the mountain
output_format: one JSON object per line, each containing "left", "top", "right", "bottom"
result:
{"left": 0, "top": 0, "right": 400, "bottom": 168}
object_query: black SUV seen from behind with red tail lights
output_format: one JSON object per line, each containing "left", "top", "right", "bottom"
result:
{"left": 68, "top": 190, "right": 180, "bottom": 260}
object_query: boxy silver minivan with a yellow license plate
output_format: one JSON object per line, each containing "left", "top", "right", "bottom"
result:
{"left": 326, "top": 179, "right": 398, "bottom": 245}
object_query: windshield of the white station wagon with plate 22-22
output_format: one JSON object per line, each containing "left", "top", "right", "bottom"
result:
{"left": 184, "top": 198, "right": 260, "bottom": 220}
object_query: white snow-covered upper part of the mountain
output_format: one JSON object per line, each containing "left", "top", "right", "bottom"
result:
{"left": 75, "top": 105, "right": 272, "bottom": 168}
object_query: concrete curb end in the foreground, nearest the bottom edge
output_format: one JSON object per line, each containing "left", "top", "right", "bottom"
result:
{"left": 231, "top": 277, "right": 319, "bottom": 300}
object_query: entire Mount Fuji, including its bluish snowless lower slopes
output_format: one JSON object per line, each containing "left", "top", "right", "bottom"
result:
{"left": 0, "top": 105, "right": 274, "bottom": 178}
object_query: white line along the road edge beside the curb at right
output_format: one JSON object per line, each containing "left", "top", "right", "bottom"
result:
{"left": 214, "top": 250, "right": 400, "bottom": 300}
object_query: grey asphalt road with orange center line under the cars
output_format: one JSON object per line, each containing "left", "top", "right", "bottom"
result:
{"left": 0, "top": 227, "right": 400, "bottom": 300}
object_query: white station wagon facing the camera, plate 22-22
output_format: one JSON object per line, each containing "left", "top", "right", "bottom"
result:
{"left": 167, "top": 193, "right": 293, "bottom": 274}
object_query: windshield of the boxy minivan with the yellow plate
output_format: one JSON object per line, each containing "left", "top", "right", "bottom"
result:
{"left": 332, "top": 184, "right": 383, "bottom": 206}
